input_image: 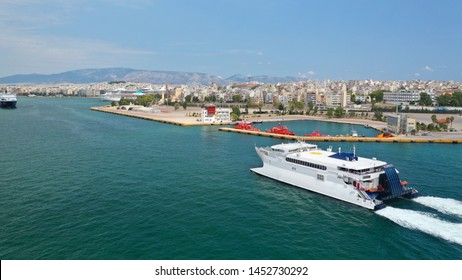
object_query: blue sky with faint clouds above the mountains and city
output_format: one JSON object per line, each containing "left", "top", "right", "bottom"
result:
{"left": 0, "top": 0, "right": 462, "bottom": 81}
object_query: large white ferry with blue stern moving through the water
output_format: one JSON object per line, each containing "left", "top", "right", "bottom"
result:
{"left": 251, "top": 142, "right": 418, "bottom": 210}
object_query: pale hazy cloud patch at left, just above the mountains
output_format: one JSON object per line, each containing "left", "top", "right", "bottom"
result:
{"left": 0, "top": 29, "right": 156, "bottom": 75}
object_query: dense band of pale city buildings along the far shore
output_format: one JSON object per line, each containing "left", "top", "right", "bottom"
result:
{"left": 0, "top": 80, "right": 462, "bottom": 111}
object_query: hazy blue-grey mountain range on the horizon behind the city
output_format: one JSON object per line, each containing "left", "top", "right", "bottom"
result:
{"left": 0, "top": 68, "right": 303, "bottom": 85}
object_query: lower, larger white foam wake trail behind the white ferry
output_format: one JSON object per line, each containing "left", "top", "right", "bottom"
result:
{"left": 376, "top": 206, "right": 462, "bottom": 245}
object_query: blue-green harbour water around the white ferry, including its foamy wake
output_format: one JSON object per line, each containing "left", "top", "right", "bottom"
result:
{"left": 0, "top": 98, "right": 462, "bottom": 260}
